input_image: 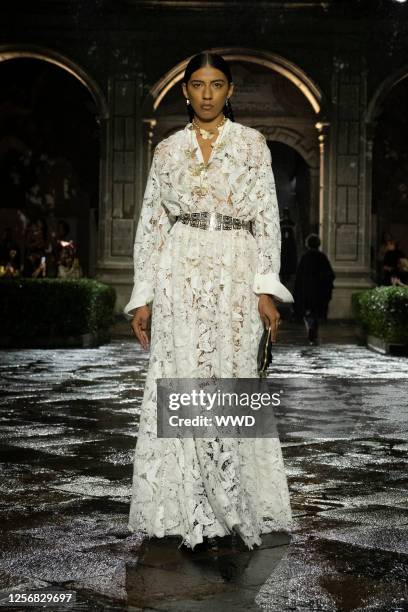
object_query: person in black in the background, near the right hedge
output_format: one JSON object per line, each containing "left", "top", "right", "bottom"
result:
{"left": 294, "top": 234, "right": 336, "bottom": 344}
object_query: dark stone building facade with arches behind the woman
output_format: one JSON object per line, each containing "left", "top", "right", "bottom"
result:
{"left": 0, "top": 0, "right": 408, "bottom": 318}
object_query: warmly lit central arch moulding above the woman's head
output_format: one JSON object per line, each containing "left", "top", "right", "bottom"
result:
{"left": 143, "top": 47, "right": 327, "bottom": 116}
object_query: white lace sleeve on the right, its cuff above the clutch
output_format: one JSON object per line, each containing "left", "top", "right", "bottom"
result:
{"left": 252, "top": 138, "right": 293, "bottom": 302}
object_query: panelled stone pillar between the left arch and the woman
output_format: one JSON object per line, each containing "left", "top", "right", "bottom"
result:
{"left": 96, "top": 76, "right": 143, "bottom": 312}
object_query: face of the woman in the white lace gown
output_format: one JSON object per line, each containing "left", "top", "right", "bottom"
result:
{"left": 183, "top": 66, "right": 234, "bottom": 121}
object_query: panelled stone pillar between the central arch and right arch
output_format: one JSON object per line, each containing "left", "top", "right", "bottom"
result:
{"left": 323, "top": 55, "right": 373, "bottom": 318}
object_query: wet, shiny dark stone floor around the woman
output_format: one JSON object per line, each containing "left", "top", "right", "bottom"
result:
{"left": 0, "top": 324, "right": 408, "bottom": 612}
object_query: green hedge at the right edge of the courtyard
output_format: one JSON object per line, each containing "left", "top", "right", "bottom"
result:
{"left": 352, "top": 286, "right": 408, "bottom": 344}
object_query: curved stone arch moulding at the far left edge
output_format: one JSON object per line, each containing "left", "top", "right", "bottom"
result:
{"left": 0, "top": 45, "right": 109, "bottom": 119}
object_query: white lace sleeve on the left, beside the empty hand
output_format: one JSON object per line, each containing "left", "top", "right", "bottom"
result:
{"left": 123, "top": 147, "right": 172, "bottom": 317}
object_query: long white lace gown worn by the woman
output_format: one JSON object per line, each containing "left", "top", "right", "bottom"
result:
{"left": 124, "top": 119, "right": 293, "bottom": 549}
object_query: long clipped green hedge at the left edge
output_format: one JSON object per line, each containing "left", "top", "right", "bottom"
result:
{"left": 0, "top": 278, "right": 116, "bottom": 344}
